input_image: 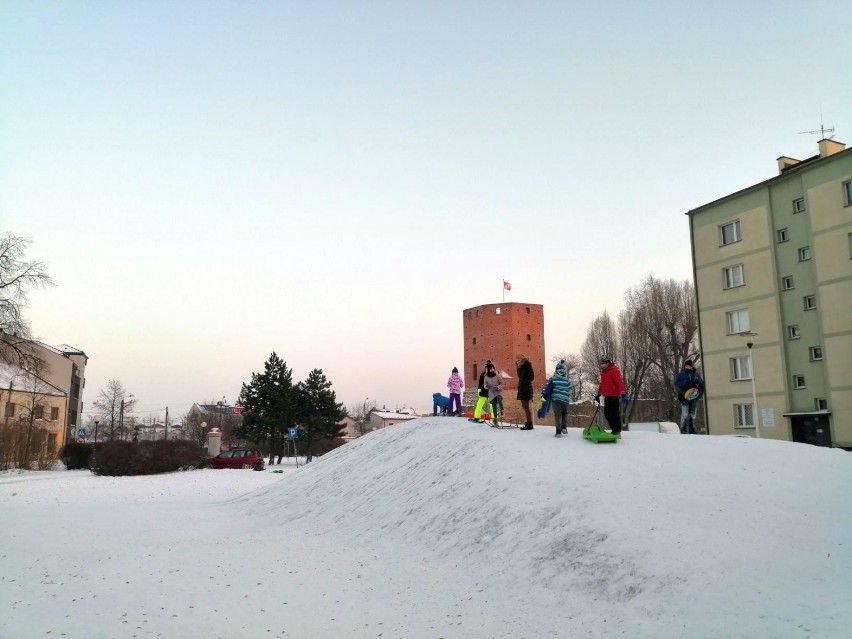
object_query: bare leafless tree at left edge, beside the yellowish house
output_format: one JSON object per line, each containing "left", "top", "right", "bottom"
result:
{"left": 0, "top": 233, "right": 53, "bottom": 370}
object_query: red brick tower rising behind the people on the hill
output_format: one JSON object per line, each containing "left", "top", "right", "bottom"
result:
{"left": 462, "top": 302, "right": 547, "bottom": 408}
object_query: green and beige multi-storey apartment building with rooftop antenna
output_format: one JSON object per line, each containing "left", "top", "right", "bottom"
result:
{"left": 687, "top": 139, "right": 852, "bottom": 448}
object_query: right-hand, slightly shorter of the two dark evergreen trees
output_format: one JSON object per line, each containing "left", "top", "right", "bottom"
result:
{"left": 296, "top": 368, "right": 346, "bottom": 461}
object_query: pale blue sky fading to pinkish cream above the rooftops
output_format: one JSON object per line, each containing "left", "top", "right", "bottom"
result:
{"left": 0, "top": 0, "right": 852, "bottom": 417}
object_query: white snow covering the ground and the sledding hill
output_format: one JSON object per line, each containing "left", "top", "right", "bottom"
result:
{"left": 0, "top": 418, "right": 852, "bottom": 639}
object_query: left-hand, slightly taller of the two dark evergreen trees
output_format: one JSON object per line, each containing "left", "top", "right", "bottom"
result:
{"left": 234, "top": 352, "right": 296, "bottom": 464}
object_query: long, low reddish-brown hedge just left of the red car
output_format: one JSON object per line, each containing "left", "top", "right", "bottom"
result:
{"left": 91, "top": 440, "right": 207, "bottom": 477}
